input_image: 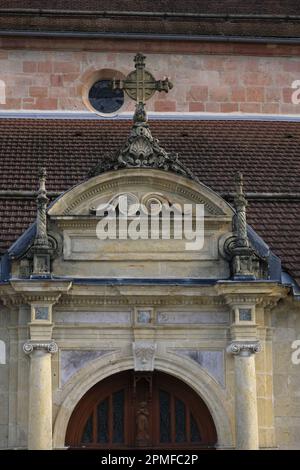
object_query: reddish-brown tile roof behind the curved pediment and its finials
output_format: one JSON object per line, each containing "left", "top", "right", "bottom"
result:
{"left": 0, "top": 119, "right": 300, "bottom": 278}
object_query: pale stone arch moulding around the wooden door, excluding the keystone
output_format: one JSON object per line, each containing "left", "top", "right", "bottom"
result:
{"left": 53, "top": 352, "right": 234, "bottom": 449}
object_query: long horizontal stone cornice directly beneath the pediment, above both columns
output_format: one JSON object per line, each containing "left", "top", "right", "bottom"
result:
{"left": 0, "top": 279, "right": 289, "bottom": 309}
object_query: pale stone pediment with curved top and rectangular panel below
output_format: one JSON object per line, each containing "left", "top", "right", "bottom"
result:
{"left": 48, "top": 168, "right": 233, "bottom": 278}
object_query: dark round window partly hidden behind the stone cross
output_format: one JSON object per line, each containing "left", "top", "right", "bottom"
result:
{"left": 88, "top": 80, "right": 124, "bottom": 114}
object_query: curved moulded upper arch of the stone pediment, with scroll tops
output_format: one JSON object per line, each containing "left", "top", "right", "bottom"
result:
{"left": 48, "top": 169, "right": 233, "bottom": 219}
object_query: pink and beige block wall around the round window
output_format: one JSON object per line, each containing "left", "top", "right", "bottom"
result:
{"left": 0, "top": 48, "right": 300, "bottom": 114}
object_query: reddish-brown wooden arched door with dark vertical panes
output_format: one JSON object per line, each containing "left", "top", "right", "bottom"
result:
{"left": 66, "top": 371, "right": 217, "bottom": 449}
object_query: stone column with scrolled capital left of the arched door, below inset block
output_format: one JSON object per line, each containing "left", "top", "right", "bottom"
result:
{"left": 23, "top": 341, "right": 58, "bottom": 450}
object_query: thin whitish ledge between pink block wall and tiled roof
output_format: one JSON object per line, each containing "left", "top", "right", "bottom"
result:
{"left": 0, "top": 110, "right": 300, "bottom": 122}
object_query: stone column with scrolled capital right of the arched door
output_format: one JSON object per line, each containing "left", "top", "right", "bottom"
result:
{"left": 227, "top": 341, "right": 261, "bottom": 450}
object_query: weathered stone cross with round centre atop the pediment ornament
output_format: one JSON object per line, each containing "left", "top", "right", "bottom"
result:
{"left": 112, "top": 53, "right": 173, "bottom": 104}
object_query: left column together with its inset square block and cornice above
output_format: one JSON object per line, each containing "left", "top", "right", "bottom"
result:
{"left": 11, "top": 279, "right": 71, "bottom": 450}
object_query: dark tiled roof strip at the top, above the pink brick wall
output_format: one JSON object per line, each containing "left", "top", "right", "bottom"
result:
{"left": 0, "top": 0, "right": 300, "bottom": 38}
